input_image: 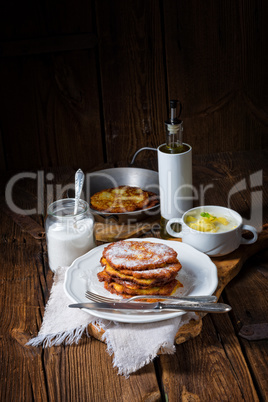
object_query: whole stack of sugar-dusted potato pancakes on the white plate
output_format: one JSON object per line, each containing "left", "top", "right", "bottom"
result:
{"left": 98, "top": 240, "right": 182, "bottom": 298}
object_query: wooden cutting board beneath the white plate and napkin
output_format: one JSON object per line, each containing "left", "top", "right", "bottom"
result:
{"left": 89, "top": 224, "right": 268, "bottom": 344}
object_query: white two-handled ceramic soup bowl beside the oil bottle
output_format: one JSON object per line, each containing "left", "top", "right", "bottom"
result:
{"left": 166, "top": 205, "right": 258, "bottom": 257}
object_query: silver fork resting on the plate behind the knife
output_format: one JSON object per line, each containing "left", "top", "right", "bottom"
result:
{"left": 85, "top": 290, "right": 217, "bottom": 303}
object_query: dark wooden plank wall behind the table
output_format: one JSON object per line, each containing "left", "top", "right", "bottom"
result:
{"left": 0, "top": 0, "right": 268, "bottom": 171}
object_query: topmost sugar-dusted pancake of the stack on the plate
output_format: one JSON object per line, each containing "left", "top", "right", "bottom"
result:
{"left": 102, "top": 240, "right": 178, "bottom": 271}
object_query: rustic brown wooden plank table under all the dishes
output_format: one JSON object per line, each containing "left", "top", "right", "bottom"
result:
{"left": 0, "top": 151, "right": 268, "bottom": 401}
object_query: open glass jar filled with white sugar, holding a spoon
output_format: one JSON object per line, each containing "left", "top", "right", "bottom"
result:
{"left": 45, "top": 198, "right": 96, "bottom": 272}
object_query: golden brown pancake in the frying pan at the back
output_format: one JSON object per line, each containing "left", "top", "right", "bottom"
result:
{"left": 90, "top": 186, "right": 158, "bottom": 213}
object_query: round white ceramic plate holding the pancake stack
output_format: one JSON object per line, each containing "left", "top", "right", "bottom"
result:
{"left": 64, "top": 238, "right": 218, "bottom": 323}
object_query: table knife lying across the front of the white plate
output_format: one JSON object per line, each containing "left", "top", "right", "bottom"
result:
{"left": 69, "top": 302, "right": 232, "bottom": 313}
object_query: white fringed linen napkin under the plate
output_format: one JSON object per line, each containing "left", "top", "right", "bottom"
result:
{"left": 27, "top": 267, "right": 196, "bottom": 376}
